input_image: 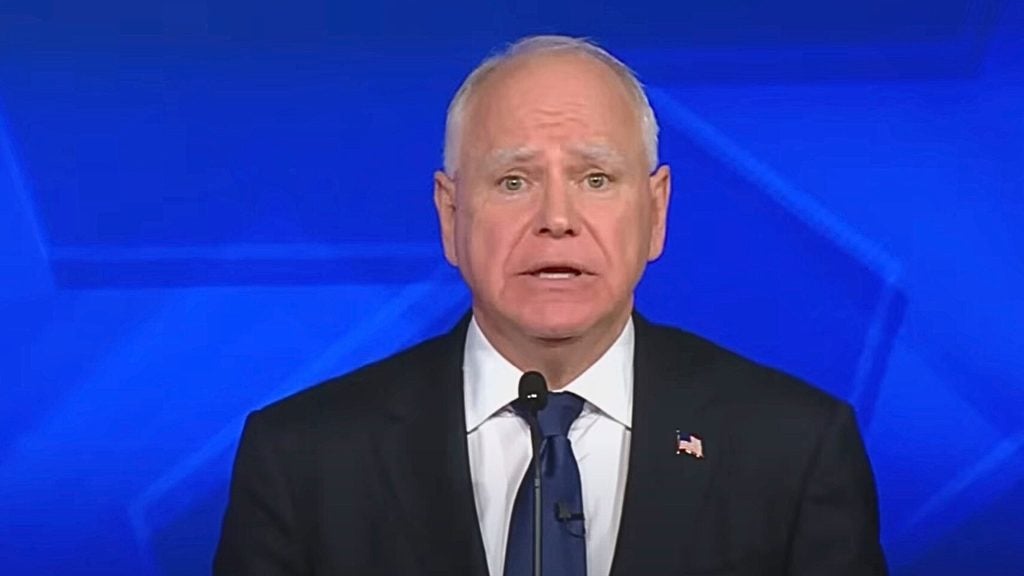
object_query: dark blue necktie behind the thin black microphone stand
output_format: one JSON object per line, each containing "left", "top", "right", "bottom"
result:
{"left": 505, "top": 393, "right": 587, "bottom": 576}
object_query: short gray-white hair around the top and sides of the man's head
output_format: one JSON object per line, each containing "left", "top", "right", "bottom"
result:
{"left": 444, "top": 36, "right": 657, "bottom": 177}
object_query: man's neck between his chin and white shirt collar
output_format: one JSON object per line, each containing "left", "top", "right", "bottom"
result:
{"left": 474, "top": 310, "right": 630, "bottom": 390}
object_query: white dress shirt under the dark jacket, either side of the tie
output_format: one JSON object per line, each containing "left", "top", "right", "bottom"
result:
{"left": 463, "top": 319, "right": 634, "bottom": 576}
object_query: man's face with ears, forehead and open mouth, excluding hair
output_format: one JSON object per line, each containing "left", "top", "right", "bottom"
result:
{"left": 434, "top": 54, "right": 670, "bottom": 340}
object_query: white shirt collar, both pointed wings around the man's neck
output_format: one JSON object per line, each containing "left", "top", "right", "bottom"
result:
{"left": 463, "top": 318, "right": 635, "bottom": 433}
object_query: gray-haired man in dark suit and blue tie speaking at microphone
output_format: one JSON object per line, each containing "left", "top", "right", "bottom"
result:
{"left": 214, "top": 37, "right": 886, "bottom": 576}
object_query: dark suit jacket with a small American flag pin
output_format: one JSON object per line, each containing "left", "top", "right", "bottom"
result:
{"left": 214, "top": 316, "right": 887, "bottom": 576}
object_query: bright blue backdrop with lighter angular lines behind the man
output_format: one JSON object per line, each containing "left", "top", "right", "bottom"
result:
{"left": 0, "top": 0, "right": 1024, "bottom": 576}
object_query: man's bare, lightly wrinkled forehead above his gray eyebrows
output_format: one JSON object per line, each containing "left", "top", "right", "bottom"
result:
{"left": 460, "top": 53, "right": 643, "bottom": 166}
